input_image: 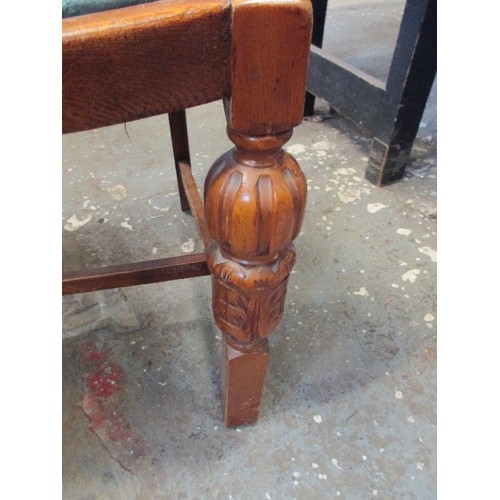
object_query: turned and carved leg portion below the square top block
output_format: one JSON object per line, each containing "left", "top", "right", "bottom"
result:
{"left": 205, "top": 129, "right": 307, "bottom": 427}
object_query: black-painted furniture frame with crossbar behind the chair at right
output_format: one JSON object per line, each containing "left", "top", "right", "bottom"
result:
{"left": 305, "top": 0, "right": 437, "bottom": 186}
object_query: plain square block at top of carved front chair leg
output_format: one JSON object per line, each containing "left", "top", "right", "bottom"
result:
{"left": 229, "top": 0, "right": 312, "bottom": 135}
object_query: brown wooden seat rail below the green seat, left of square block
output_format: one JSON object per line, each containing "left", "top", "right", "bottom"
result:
{"left": 62, "top": 0, "right": 231, "bottom": 133}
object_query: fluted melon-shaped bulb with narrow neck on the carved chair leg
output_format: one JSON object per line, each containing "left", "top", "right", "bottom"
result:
{"left": 205, "top": 130, "right": 307, "bottom": 265}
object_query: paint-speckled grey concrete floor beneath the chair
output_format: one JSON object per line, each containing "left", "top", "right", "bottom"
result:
{"left": 62, "top": 2, "right": 437, "bottom": 500}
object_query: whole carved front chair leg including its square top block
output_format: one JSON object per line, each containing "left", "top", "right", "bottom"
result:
{"left": 205, "top": 0, "right": 312, "bottom": 427}
